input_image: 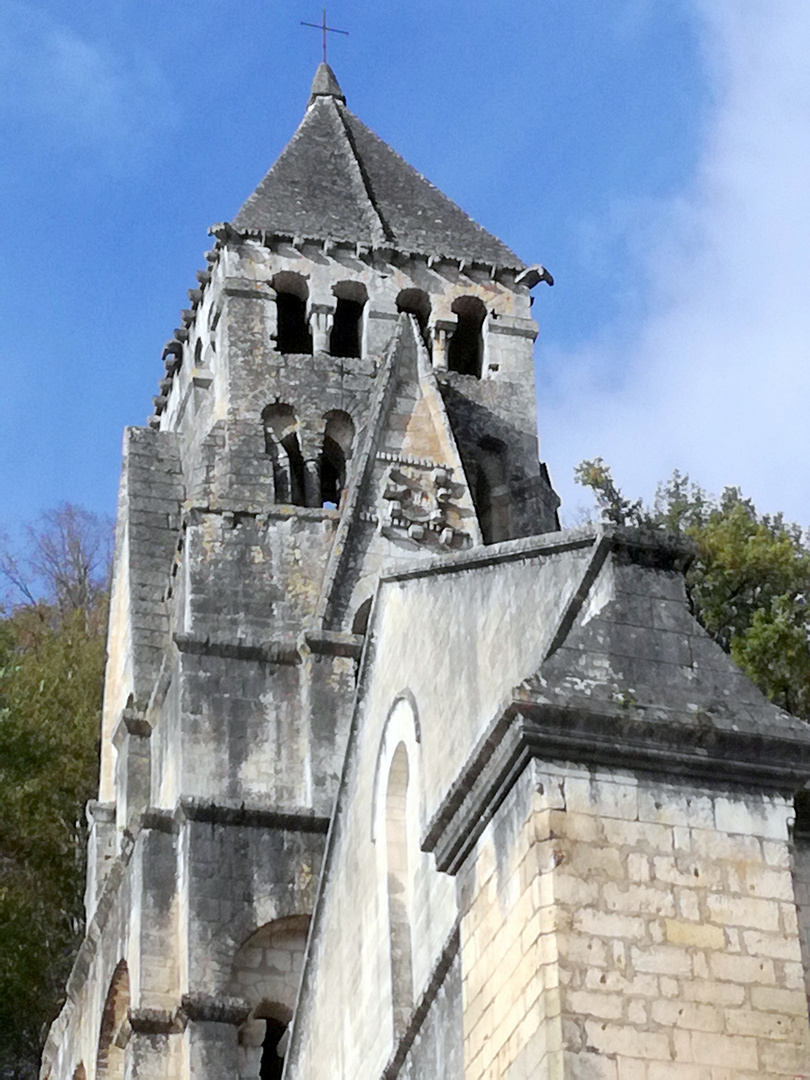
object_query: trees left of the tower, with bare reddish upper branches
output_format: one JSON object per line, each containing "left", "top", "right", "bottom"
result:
{"left": 0, "top": 505, "right": 109, "bottom": 1078}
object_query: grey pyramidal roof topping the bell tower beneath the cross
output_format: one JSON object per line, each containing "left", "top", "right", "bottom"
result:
{"left": 232, "top": 64, "right": 524, "bottom": 269}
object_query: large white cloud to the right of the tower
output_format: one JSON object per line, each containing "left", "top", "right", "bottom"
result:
{"left": 540, "top": 0, "right": 810, "bottom": 525}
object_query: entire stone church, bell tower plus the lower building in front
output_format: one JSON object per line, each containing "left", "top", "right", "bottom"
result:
{"left": 47, "top": 64, "right": 810, "bottom": 1080}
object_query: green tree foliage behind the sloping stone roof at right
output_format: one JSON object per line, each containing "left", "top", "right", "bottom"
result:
{"left": 575, "top": 458, "right": 810, "bottom": 719}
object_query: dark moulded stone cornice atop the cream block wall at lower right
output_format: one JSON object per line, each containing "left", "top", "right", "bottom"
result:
{"left": 421, "top": 697, "right": 810, "bottom": 874}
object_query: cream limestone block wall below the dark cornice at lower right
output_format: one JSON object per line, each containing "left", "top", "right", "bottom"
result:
{"left": 461, "top": 764, "right": 810, "bottom": 1080}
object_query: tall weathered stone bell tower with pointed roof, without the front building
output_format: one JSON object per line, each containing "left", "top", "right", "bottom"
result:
{"left": 42, "top": 64, "right": 558, "bottom": 1080}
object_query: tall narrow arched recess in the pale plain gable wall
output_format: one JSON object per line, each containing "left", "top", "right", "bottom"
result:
{"left": 386, "top": 742, "right": 414, "bottom": 1036}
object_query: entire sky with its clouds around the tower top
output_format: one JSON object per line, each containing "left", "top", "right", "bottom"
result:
{"left": 0, "top": 0, "right": 810, "bottom": 529}
